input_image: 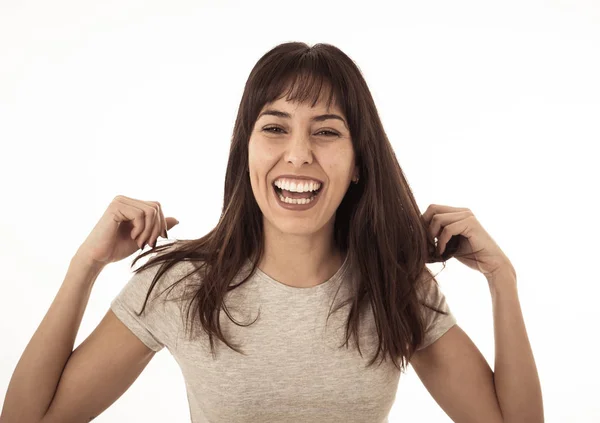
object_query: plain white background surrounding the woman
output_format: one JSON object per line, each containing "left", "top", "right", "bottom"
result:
{"left": 0, "top": 0, "right": 600, "bottom": 423}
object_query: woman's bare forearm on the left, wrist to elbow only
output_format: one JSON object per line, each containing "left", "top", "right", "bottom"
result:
{"left": 0, "top": 257, "right": 102, "bottom": 423}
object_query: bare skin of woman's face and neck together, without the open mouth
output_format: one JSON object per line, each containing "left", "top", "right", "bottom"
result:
{"left": 248, "top": 99, "right": 359, "bottom": 287}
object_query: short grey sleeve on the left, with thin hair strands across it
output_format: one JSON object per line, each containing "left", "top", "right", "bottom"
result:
{"left": 110, "top": 264, "right": 180, "bottom": 352}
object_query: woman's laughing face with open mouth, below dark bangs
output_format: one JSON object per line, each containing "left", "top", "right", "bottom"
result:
{"left": 248, "top": 99, "right": 358, "bottom": 235}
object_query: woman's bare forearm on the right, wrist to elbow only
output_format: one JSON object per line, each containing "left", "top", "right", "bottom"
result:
{"left": 488, "top": 271, "right": 544, "bottom": 423}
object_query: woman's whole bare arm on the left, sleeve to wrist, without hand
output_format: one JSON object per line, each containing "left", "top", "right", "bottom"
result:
{"left": 0, "top": 258, "right": 154, "bottom": 423}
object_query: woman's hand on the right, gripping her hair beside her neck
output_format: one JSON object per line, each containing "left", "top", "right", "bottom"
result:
{"left": 422, "top": 204, "right": 515, "bottom": 280}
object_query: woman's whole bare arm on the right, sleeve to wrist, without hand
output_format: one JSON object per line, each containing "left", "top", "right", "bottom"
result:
{"left": 411, "top": 273, "right": 544, "bottom": 423}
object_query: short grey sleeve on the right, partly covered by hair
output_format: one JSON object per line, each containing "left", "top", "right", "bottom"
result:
{"left": 417, "top": 280, "right": 457, "bottom": 351}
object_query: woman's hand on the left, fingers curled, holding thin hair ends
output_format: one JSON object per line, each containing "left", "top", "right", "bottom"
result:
{"left": 75, "top": 195, "right": 179, "bottom": 266}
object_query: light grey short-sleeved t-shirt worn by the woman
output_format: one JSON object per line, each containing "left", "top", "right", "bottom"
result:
{"left": 111, "top": 253, "right": 456, "bottom": 423}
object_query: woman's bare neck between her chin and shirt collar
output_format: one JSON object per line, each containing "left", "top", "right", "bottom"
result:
{"left": 258, "top": 222, "right": 344, "bottom": 288}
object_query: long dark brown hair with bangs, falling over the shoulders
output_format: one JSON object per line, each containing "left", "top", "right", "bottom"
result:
{"left": 127, "top": 42, "right": 482, "bottom": 370}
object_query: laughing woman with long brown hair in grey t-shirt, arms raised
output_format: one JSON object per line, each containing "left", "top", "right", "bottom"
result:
{"left": 2, "top": 43, "right": 543, "bottom": 423}
